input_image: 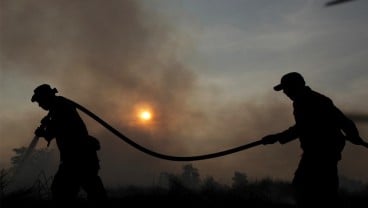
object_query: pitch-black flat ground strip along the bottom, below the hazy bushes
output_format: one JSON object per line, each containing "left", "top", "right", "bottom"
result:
{"left": 1, "top": 186, "right": 368, "bottom": 208}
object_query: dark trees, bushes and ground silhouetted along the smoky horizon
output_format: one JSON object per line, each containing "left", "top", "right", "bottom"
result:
{"left": 0, "top": 147, "right": 368, "bottom": 208}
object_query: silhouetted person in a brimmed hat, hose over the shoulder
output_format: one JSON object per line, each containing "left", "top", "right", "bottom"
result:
{"left": 32, "top": 84, "right": 107, "bottom": 208}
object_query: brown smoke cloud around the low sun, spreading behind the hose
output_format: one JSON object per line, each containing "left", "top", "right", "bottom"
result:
{"left": 0, "top": 0, "right": 367, "bottom": 188}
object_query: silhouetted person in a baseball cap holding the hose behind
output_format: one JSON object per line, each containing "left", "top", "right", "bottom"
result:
{"left": 262, "top": 72, "right": 368, "bottom": 207}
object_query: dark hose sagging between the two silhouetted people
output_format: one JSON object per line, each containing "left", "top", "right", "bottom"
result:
{"left": 67, "top": 99, "right": 263, "bottom": 161}
